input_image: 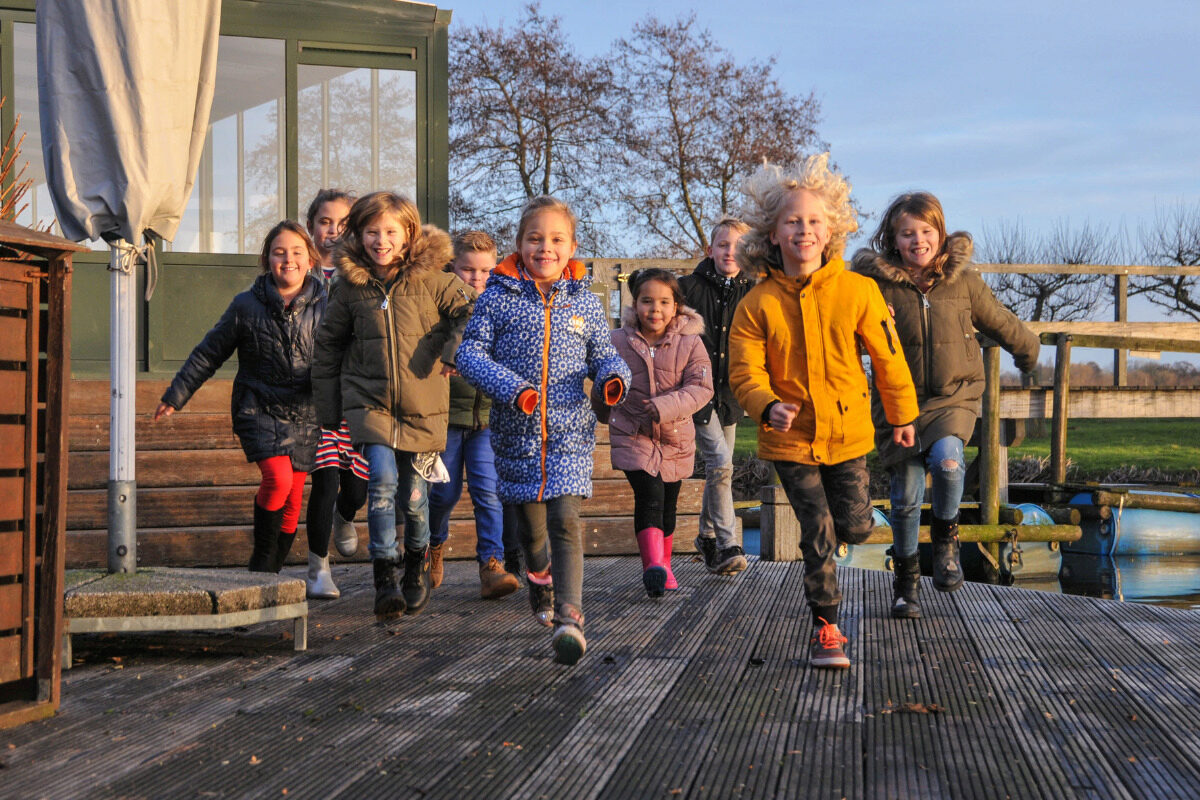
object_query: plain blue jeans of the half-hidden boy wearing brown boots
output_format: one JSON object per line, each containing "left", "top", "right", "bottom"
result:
{"left": 430, "top": 425, "right": 516, "bottom": 564}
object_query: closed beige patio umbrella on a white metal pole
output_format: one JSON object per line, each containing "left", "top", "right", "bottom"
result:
{"left": 37, "top": 0, "right": 221, "bottom": 572}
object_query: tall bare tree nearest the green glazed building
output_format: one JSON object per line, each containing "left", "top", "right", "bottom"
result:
{"left": 450, "top": 4, "right": 612, "bottom": 251}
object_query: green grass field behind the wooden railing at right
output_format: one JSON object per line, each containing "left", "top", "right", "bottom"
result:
{"left": 734, "top": 420, "right": 1200, "bottom": 480}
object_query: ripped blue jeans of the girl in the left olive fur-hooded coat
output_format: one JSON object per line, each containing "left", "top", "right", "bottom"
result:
{"left": 362, "top": 444, "right": 430, "bottom": 560}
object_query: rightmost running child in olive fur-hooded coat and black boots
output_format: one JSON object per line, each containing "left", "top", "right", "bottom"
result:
{"left": 853, "top": 192, "right": 1040, "bottom": 618}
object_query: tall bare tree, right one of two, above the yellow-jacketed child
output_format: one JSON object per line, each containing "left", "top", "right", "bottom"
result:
{"left": 606, "top": 16, "right": 823, "bottom": 257}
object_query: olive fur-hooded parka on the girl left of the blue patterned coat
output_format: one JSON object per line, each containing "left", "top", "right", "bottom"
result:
{"left": 312, "top": 225, "right": 475, "bottom": 452}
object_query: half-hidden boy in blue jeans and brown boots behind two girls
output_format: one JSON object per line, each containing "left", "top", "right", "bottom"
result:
{"left": 430, "top": 230, "right": 521, "bottom": 600}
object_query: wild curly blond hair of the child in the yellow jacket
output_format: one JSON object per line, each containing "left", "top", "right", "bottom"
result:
{"left": 738, "top": 152, "right": 858, "bottom": 275}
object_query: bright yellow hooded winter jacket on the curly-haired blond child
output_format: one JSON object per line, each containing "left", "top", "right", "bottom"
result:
{"left": 730, "top": 258, "right": 918, "bottom": 464}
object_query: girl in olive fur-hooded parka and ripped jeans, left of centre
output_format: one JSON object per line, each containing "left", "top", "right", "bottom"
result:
{"left": 312, "top": 192, "right": 475, "bottom": 619}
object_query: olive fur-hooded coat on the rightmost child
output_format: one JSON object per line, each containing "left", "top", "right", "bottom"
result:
{"left": 853, "top": 233, "right": 1040, "bottom": 465}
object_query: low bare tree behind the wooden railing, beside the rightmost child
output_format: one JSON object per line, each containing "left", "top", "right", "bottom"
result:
{"left": 979, "top": 219, "right": 1120, "bottom": 321}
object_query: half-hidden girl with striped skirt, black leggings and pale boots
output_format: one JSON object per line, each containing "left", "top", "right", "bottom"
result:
{"left": 305, "top": 188, "right": 367, "bottom": 600}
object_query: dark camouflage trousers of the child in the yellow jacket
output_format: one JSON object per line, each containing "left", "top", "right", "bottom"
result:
{"left": 775, "top": 457, "right": 874, "bottom": 622}
